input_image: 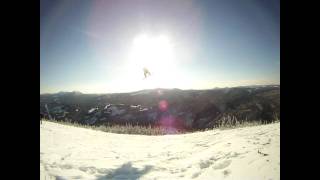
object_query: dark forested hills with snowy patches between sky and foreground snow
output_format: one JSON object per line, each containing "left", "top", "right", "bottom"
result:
{"left": 40, "top": 85, "right": 280, "bottom": 129}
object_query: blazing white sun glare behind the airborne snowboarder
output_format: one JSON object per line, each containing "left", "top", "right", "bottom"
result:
{"left": 126, "top": 34, "right": 175, "bottom": 89}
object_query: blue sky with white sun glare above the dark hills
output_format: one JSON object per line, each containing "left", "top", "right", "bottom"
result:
{"left": 40, "top": 0, "right": 280, "bottom": 93}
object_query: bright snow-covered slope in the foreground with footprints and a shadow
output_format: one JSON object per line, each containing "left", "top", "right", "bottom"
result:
{"left": 40, "top": 121, "right": 280, "bottom": 180}
